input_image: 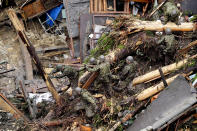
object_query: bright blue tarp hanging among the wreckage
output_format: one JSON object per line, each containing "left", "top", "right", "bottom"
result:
{"left": 46, "top": 4, "right": 63, "bottom": 26}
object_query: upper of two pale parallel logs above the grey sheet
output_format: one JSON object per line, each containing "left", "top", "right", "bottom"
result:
{"left": 132, "top": 55, "right": 197, "bottom": 86}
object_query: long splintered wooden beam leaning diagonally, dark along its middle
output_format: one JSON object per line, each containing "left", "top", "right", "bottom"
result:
{"left": 8, "top": 9, "right": 62, "bottom": 106}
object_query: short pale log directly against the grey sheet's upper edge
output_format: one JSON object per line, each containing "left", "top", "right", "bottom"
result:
{"left": 136, "top": 75, "right": 179, "bottom": 101}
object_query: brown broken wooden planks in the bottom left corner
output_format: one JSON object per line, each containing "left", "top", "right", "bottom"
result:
{"left": 0, "top": 93, "right": 29, "bottom": 122}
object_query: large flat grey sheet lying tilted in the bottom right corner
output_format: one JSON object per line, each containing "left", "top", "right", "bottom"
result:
{"left": 128, "top": 76, "right": 197, "bottom": 131}
